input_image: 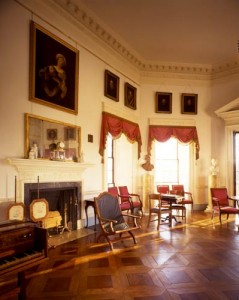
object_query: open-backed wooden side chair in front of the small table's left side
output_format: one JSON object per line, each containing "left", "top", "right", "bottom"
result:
{"left": 147, "top": 194, "right": 170, "bottom": 230}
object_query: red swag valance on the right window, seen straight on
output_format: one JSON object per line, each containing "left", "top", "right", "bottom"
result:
{"left": 148, "top": 125, "right": 200, "bottom": 159}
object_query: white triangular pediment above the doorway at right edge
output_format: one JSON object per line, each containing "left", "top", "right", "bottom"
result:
{"left": 215, "top": 98, "right": 239, "bottom": 126}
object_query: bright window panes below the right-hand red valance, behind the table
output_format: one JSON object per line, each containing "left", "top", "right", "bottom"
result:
{"left": 155, "top": 138, "right": 190, "bottom": 190}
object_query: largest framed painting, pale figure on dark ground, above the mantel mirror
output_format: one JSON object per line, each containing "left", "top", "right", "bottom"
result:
{"left": 29, "top": 21, "right": 79, "bottom": 114}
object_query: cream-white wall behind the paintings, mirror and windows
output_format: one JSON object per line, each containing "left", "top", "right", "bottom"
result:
{"left": 0, "top": 0, "right": 239, "bottom": 213}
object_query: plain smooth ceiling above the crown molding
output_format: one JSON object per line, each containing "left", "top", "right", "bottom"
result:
{"left": 75, "top": 0, "right": 239, "bottom": 65}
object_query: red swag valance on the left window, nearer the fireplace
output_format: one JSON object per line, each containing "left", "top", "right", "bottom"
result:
{"left": 99, "top": 112, "right": 142, "bottom": 158}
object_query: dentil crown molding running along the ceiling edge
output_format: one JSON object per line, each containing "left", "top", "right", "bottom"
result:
{"left": 51, "top": 0, "right": 239, "bottom": 79}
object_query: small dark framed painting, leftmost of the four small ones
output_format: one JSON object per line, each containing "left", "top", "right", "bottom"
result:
{"left": 105, "top": 70, "right": 119, "bottom": 102}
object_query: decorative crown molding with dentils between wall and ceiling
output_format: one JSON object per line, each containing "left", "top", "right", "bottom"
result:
{"left": 24, "top": 0, "right": 239, "bottom": 80}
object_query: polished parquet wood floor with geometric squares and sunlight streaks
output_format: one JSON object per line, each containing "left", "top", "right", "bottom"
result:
{"left": 2, "top": 212, "right": 239, "bottom": 300}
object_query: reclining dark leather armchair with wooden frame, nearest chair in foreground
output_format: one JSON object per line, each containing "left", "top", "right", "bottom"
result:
{"left": 94, "top": 192, "right": 141, "bottom": 250}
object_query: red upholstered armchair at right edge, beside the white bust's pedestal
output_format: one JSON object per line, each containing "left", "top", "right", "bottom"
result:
{"left": 211, "top": 188, "right": 239, "bottom": 223}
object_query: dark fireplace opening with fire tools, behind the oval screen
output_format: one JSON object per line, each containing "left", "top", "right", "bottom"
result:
{"left": 24, "top": 182, "right": 81, "bottom": 230}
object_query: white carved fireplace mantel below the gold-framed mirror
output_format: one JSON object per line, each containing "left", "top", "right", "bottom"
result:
{"left": 8, "top": 158, "right": 94, "bottom": 201}
